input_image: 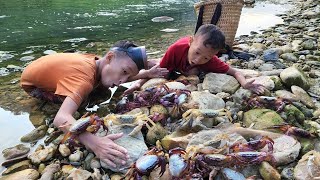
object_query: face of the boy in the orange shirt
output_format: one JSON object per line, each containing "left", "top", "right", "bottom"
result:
{"left": 101, "top": 55, "right": 139, "bottom": 87}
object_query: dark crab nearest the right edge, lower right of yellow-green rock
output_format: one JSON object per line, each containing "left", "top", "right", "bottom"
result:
{"left": 267, "top": 123, "right": 315, "bottom": 138}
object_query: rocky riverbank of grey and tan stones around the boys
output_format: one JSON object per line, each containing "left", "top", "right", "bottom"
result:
{"left": 0, "top": 0, "right": 320, "bottom": 180}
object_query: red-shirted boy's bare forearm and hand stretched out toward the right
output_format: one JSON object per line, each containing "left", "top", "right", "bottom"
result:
{"left": 227, "top": 67, "right": 266, "bottom": 94}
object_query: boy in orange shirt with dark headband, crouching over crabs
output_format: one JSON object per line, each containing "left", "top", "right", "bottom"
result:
{"left": 21, "top": 41, "right": 167, "bottom": 167}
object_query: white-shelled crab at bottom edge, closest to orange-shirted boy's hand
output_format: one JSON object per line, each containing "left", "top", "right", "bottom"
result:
{"left": 125, "top": 147, "right": 166, "bottom": 179}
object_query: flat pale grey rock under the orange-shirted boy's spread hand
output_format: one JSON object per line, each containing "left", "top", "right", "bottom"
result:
{"left": 100, "top": 125, "right": 148, "bottom": 173}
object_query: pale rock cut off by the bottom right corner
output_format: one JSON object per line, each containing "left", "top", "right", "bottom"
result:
{"left": 294, "top": 151, "right": 320, "bottom": 180}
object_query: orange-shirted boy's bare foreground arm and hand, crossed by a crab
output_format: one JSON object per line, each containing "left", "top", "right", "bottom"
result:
{"left": 53, "top": 97, "right": 128, "bottom": 167}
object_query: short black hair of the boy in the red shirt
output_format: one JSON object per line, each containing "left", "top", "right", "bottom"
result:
{"left": 195, "top": 24, "right": 226, "bottom": 50}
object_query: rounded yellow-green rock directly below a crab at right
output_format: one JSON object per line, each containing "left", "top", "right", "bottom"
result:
{"left": 243, "top": 109, "right": 284, "bottom": 129}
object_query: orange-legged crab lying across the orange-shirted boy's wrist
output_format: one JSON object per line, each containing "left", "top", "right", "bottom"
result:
{"left": 60, "top": 114, "right": 108, "bottom": 147}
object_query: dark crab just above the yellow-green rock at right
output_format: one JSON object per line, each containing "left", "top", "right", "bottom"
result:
{"left": 244, "top": 95, "right": 291, "bottom": 112}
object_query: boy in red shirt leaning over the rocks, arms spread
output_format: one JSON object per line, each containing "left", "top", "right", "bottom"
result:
{"left": 125, "top": 24, "right": 265, "bottom": 94}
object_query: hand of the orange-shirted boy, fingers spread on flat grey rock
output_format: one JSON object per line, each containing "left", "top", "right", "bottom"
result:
{"left": 80, "top": 133, "right": 129, "bottom": 168}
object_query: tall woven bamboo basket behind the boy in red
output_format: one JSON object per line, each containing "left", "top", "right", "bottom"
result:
{"left": 194, "top": 0, "right": 243, "bottom": 47}
